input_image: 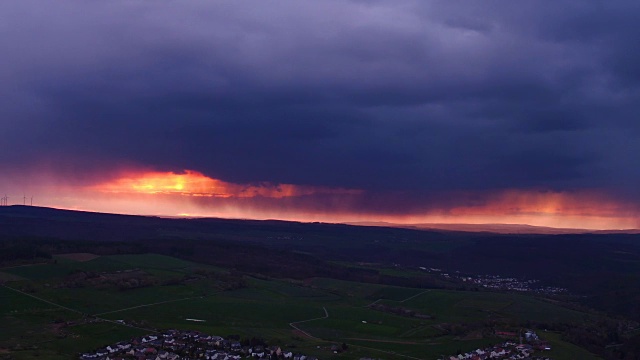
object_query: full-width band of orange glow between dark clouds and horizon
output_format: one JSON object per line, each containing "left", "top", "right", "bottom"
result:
{"left": 13, "top": 170, "right": 640, "bottom": 229}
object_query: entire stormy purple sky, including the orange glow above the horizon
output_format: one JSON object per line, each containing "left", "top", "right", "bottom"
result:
{"left": 0, "top": 0, "right": 640, "bottom": 229}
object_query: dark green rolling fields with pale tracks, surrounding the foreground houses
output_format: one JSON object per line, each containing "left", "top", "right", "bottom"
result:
{"left": 0, "top": 254, "right": 596, "bottom": 360}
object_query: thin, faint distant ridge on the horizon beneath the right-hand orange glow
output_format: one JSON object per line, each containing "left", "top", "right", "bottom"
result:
{"left": 348, "top": 222, "right": 640, "bottom": 235}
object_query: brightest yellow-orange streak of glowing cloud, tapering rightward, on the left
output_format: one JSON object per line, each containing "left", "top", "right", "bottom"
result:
{"left": 92, "top": 170, "right": 361, "bottom": 198}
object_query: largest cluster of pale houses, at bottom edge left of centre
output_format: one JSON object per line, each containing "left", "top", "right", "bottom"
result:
{"left": 79, "top": 330, "right": 318, "bottom": 360}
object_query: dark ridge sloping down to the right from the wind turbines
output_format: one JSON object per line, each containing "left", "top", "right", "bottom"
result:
{"left": 0, "top": 205, "right": 442, "bottom": 243}
